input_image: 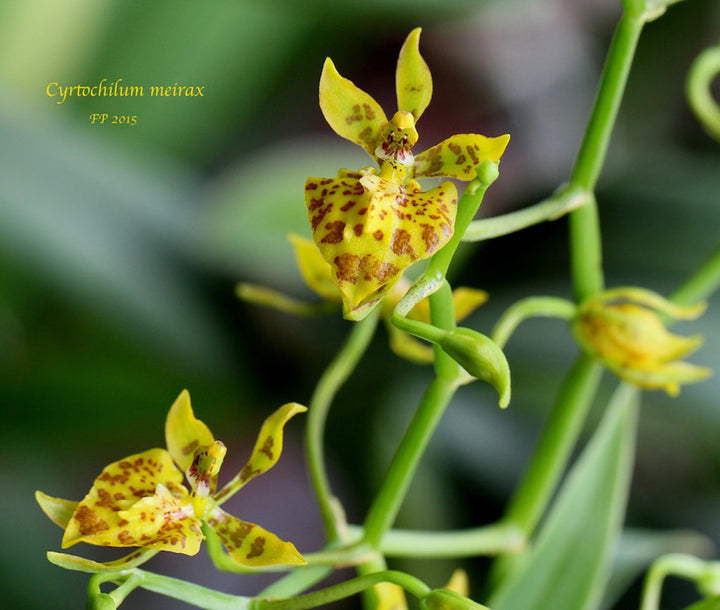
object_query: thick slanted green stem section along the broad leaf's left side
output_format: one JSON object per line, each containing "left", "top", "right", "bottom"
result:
{"left": 491, "top": 354, "right": 602, "bottom": 584}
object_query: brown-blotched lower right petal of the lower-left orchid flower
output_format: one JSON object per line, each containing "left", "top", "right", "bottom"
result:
{"left": 207, "top": 507, "right": 306, "bottom": 567}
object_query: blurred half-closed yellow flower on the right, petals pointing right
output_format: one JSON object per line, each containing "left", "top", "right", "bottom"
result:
{"left": 572, "top": 288, "right": 711, "bottom": 396}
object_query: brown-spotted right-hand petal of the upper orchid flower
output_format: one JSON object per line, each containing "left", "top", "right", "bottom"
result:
{"left": 415, "top": 133, "right": 510, "bottom": 180}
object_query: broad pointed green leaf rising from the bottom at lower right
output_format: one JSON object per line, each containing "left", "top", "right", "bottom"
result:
{"left": 489, "top": 385, "right": 637, "bottom": 610}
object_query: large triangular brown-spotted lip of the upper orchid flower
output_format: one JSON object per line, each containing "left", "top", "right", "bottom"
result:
{"left": 305, "top": 170, "right": 457, "bottom": 320}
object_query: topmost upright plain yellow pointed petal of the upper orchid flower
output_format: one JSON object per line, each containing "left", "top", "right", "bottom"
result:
{"left": 395, "top": 28, "right": 432, "bottom": 121}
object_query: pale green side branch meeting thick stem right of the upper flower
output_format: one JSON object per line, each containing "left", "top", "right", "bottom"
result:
{"left": 462, "top": 185, "right": 593, "bottom": 242}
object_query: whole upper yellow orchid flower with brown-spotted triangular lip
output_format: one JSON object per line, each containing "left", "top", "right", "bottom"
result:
{"left": 305, "top": 28, "right": 509, "bottom": 320}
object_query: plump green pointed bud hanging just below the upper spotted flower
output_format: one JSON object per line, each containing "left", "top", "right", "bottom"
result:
{"left": 439, "top": 327, "right": 510, "bottom": 409}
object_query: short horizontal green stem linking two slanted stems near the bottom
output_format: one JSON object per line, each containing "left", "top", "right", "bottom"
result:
{"left": 350, "top": 523, "right": 526, "bottom": 558}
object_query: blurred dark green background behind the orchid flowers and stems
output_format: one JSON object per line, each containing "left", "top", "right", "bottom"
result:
{"left": 0, "top": 0, "right": 720, "bottom": 610}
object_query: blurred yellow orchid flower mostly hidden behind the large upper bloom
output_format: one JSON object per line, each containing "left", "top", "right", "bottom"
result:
{"left": 290, "top": 234, "right": 488, "bottom": 364}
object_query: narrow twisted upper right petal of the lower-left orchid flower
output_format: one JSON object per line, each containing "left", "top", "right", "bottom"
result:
{"left": 215, "top": 402, "right": 307, "bottom": 504}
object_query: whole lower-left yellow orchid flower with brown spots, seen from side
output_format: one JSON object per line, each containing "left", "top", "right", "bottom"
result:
{"left": 38, "top": 391, "right": 306, "bottom": 567}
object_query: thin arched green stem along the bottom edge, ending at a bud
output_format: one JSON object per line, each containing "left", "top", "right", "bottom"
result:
{"left": 249, "top": 570, "right": 430, "bottom": 610}
